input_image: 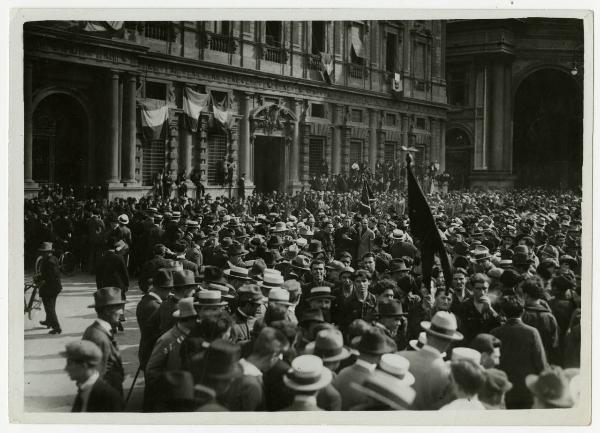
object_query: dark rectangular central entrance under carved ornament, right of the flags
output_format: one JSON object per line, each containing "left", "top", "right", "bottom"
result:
{"left": 254, "top": 136, "right": 285, "bottom": 193}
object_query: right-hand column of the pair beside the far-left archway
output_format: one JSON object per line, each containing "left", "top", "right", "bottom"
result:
{"left": 121, "top": 75, "right": 137, "bottom": 184}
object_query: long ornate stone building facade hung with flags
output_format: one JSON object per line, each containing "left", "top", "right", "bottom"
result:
{"left": 24, "top": 21, "right": 448, "bottom": 197}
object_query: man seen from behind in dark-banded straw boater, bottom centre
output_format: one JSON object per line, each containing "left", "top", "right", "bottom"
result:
{"left": 282, "top": 355, "right": 332, "bottom": 412}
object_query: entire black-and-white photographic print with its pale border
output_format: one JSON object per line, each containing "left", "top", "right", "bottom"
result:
{"left": 9, "top": 5, "right": 593, "bottom": 425}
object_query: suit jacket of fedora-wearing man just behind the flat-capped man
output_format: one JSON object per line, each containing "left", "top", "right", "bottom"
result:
{"left": 81, "top": 322, "right": 125, "bottom": 395}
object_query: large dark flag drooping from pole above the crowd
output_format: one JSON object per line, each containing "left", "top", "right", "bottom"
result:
{"left": 406, "top": 154, "right": 452, "bottom": 289}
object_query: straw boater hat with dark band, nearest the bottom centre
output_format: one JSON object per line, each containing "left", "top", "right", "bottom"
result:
{"left": 283, "top": 355, "right": 333, "bottom": 392}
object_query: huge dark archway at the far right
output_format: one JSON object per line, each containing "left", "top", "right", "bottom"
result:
{"left": 513, "top": 69, "right": 583, "bottom": 188}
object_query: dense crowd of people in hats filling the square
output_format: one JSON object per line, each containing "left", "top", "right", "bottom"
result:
{"left": 25, "top": 181, "right": 582, "bottom": 412}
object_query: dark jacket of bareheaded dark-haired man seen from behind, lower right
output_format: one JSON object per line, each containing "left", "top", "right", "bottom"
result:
{"left": 490, "top": 319, "right": 546, "bottom": 409}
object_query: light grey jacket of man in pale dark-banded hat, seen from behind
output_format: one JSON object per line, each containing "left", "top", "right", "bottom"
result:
{"left": 399, "top": 346, "right": 454, "bottom": 410}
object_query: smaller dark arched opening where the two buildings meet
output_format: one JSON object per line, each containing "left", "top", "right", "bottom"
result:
{"left": 446, "top": 128, "right": 472, "bottom": 189}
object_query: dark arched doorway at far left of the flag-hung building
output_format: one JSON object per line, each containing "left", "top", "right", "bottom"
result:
{"left": 32, "top": 93, "right": 89, "bottom": 185}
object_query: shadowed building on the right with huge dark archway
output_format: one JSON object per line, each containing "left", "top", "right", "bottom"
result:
{"left": 445, "top": 18, "right": 583, "bottom": 188}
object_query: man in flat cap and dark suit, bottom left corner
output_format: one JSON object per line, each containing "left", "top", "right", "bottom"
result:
{"left": 61, "top": 340, "right": 124, "bottom": 412}
